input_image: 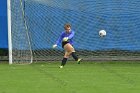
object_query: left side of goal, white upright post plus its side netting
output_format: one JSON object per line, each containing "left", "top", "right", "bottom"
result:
{"left": 7, "top": 0, "right": 33, "bottom": 64}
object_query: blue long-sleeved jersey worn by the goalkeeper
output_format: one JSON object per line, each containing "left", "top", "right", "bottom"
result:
{"left": 56, "top": 30, "right": 74, "bottom": 45}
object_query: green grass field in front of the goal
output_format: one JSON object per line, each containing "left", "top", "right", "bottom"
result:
{"left": 0, "top": 62, "right": 140, "bottom": 93}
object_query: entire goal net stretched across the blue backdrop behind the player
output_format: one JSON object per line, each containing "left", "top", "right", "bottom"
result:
{"left": 8, "top": 0, "right": 140, "bottom": 63}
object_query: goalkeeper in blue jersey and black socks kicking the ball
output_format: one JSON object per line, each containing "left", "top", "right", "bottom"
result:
{"left": 53, "top": 23, "right": 81, "bottom": 68}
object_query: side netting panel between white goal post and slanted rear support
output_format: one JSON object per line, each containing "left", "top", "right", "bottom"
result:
{"left": 11, "top": 0, "right": 32, "bottom": 63}
